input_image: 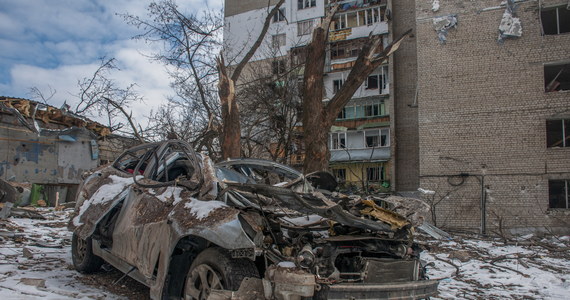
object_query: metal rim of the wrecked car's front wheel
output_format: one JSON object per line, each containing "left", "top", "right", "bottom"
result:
{"left": 184, "top": 264, "right": 224, "bottom": 300}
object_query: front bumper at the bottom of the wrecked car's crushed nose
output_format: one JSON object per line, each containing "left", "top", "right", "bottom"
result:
{"left": 316, "top": 280, "right": 439, "bottom": 300}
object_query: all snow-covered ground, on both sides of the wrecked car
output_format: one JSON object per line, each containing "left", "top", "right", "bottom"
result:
{"left": 0, "top": 209, "right": 570, "bottom": 300}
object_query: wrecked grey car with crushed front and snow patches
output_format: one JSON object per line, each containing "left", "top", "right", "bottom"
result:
{"left": 69, "top": 140, "right": 438, "bottom": 299}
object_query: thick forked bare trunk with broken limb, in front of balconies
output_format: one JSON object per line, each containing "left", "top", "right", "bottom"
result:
{"left": 303, "top": 5, "right": 411, "bottom": 172}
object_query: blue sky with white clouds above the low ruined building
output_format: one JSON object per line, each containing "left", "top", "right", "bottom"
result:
{"left": 0, "top": 0, "right": 223, "bottom": 121}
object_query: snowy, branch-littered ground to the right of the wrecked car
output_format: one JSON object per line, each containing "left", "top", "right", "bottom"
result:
{"left": 422, "top": 235, "right": 570, "bottom": 299}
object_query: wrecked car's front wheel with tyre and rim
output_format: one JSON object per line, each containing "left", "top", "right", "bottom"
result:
{"left": 184, "top": 248, "right": 259, "bottom": 300}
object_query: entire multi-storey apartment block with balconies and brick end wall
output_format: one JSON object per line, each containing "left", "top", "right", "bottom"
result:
{"left": 224, "top": 0, "right": 570, "bottom": 233}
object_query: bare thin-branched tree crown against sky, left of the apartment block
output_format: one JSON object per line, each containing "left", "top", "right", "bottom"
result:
{"left": 122, "top": 0, "right": 223, "bottom": 156}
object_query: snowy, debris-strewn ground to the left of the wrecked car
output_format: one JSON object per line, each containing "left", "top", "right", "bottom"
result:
{"left": 0, "top": 209, "right": 148, "bottom": 300}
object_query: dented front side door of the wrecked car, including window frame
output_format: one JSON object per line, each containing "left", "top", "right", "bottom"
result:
{"left": 111, "top": 141, "right": 200, "bottom": 278}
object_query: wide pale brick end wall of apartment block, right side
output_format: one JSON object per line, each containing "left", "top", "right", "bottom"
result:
{"left": 412, "top": 1, "right": 570, "bottom": 232}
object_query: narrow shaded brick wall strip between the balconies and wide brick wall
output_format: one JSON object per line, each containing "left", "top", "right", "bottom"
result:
{"left": 391, "top": 0, "right": 427, "bottom": 191}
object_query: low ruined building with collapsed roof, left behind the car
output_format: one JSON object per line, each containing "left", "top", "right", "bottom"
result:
{"left": 0, "top": 97, "right": 136, "bottom": 206}
